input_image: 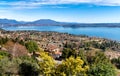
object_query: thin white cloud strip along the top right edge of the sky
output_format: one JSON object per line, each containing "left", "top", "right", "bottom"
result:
{"left": 31, "top": 0, "right": 120, "bottom": 6}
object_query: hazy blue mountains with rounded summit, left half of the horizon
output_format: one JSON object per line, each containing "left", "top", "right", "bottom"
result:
{"left": 0, "top": 19, "right": 66, "bottom": 26}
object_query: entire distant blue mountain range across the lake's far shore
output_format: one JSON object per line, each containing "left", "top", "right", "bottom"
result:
{"left": 0, "top": 19, "right": 120, "bottom": 28}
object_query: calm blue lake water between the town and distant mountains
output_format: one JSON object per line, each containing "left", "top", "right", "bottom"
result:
{"left": 3, "top": 26, "right": 120, "bottom": 41}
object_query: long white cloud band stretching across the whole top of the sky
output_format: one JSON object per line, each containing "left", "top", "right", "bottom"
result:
{"left": 0, "top": 0, "right": 120, "bottom": 9}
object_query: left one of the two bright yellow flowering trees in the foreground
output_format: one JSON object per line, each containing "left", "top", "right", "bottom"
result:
{"left": 39, "top": 52, "right": 55, "bottom": 76}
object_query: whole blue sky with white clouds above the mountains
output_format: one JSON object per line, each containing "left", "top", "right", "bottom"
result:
{"left": 0, "top": 0, "right": 120, "bottom": 23}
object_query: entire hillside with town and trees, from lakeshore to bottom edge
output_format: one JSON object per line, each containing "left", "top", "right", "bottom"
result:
{"left": 0, "top": 30, "right": 120, "bottom": 76}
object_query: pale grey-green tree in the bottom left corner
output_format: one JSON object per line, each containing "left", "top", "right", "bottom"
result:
{"left": 0, "top": 57, "right": 21, "bottom": 76}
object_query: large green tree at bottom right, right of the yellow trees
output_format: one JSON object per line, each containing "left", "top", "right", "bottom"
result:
{"left": 88, "top": 52, "right": 116, "bottom": 76}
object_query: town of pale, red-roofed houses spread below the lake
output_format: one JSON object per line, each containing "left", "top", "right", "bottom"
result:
{"left": 0, "top": 30, "right": 120, "bottom": 58}
